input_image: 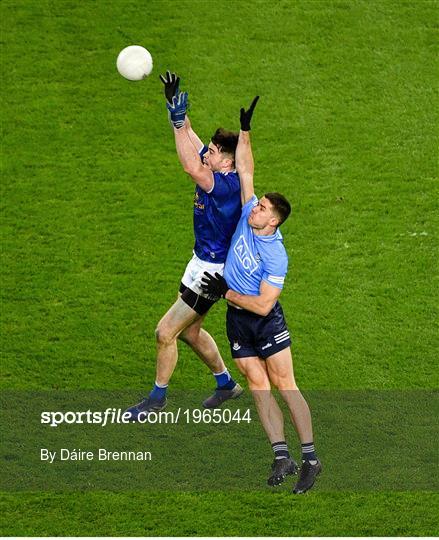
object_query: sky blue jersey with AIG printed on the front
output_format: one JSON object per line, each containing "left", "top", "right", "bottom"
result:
{"left": 224, "top": 195, "right": 288, "bottom": 296}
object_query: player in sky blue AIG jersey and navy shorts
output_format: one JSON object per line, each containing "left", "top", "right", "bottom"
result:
{"left": 202, "top": 98, "right": 321, "bottom": 493}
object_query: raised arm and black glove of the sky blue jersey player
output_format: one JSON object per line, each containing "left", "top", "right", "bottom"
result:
{"left": 235, "top": 96, "right": 259, "bottom": 205}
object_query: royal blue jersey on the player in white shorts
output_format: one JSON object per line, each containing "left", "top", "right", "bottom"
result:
{"left": 194, "top": 146, "right": 241, "bottom": 263}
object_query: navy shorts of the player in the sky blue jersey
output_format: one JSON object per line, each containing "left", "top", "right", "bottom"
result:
{"left": 227, "top": 302, "right": 291, "bottom": 359}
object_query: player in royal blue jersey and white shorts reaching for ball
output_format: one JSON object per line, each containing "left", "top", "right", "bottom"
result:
{"left": 127, "top": 71, "right": 243, "bottom": 420}
